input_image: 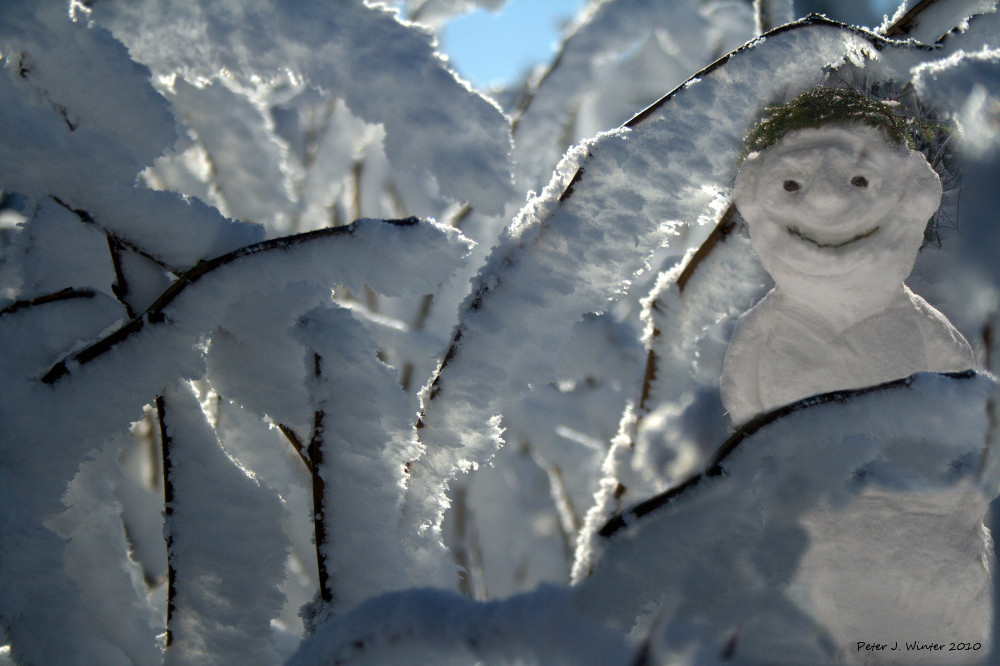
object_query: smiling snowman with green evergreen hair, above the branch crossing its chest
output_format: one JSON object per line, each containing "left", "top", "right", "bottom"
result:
{"left": 721, "top": 87, "right": 974, "bottom": 425}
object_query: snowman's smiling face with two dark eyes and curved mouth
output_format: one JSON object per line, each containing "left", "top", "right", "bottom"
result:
{"left": 734, "top": 125, "right": 941, "bottom": 286}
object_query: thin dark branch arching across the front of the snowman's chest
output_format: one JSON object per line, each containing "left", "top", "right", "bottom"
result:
{"left": 598, "top": 370, "right": 976, "bottom": 538}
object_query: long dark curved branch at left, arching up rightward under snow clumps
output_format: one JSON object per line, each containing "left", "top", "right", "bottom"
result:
{"left": 41, "top": 217, "right": 419, "bottom": 384}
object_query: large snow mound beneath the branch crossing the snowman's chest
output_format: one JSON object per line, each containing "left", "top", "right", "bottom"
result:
{"left": 575, "top": 374, "right": 996, "bottom": 664}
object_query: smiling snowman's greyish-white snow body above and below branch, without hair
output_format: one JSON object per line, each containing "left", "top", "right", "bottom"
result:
{"left": 722, "top": 114, "right": 992, "bottom": 664}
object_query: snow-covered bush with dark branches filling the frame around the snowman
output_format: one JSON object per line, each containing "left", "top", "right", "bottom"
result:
{"left": 0, "top": 0, "right": 1000, "bottom": 664}
